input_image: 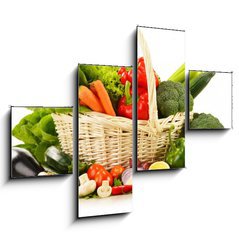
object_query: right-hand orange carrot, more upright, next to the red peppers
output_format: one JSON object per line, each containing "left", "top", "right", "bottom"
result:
{"left": 90, "top": 80, "right": 116, "bottom": 116}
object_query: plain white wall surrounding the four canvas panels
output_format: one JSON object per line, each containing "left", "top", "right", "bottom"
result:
{"left": 0, "top": 0, "right": 239, "bottom": 240}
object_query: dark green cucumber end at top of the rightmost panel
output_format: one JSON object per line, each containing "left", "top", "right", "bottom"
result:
{"left": 189, "top": 72, "right": 216, "bottom": 98}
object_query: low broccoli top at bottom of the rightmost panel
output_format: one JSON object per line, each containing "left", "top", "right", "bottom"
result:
{"left": 190, "top": 113, "right": 224, "bottom": 129}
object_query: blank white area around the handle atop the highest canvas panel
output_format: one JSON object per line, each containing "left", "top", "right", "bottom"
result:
{"left": 138, "top": 27, "right": 185, "bottom": 81}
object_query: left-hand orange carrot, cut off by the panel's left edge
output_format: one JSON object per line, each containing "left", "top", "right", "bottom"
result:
{"left": 79, "top": 85, "right": 104, "bottom": 113}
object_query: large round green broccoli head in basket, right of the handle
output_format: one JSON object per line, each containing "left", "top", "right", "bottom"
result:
{"left": 157, "top": 81, "right": 193, "bottom": 118}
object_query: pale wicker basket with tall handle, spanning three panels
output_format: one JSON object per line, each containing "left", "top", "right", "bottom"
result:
{"left": 53, "top": 31, "right": 185, "bottom": 169}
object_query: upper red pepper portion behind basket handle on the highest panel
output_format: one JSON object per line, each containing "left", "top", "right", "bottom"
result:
{"left": 137, "top": 57, "right": 159, "bottom": 89}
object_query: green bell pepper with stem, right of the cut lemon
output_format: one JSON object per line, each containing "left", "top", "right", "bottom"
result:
{"left": 165, "top": 128, "right": 185, "bottom": 168}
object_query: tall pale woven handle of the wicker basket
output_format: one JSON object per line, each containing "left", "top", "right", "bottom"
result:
{"left": 138, "top": 30, "right": 161, "bottom": 130}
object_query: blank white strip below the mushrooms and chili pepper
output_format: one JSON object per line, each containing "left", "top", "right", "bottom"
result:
{"left": 79, "top": 194, "right": 132, "bottom": 217}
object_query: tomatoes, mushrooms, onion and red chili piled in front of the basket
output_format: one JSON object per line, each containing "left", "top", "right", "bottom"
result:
{"left": 79, "top": 163, "right": 132, "bottom": 199}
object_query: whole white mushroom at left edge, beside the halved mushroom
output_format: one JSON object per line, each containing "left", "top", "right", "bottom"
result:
{"left": 79, "top": 173, "right": 96, "bottom": 197}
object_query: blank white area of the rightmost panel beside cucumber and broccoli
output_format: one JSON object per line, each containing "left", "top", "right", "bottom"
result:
{"left": 190, "top": 72, "right": 232, "bottom": 128}
